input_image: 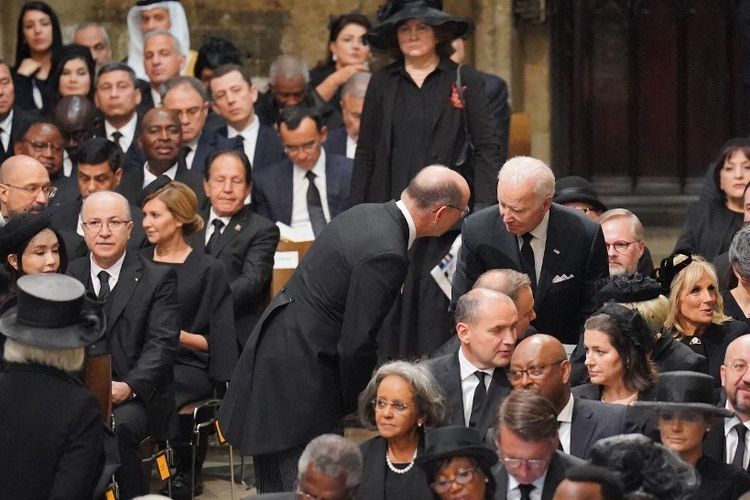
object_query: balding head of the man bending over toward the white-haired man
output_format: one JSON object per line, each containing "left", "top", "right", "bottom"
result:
{"left": 401, "top": 165, "right": 470, "bottom": 237}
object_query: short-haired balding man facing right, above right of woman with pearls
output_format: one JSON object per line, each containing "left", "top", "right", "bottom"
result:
{"left": 427, "top": 288, "right": 518, "bottom": 435}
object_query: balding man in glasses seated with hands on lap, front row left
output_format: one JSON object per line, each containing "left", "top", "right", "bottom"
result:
{"left": 68, "top": 191, "right": 180, "bottom": 499}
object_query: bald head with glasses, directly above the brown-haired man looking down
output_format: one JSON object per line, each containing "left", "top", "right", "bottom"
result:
{"left": 509, "top": 333, "right": 570, "bottom": 413}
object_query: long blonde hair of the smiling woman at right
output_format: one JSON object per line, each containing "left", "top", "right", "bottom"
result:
{"left": 664, "top": 256, "right": 732, "bottom": 338}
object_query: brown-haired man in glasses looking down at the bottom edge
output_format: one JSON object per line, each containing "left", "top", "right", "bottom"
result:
{"left": 492, "top": 390, "right": 585, "bottom": 500}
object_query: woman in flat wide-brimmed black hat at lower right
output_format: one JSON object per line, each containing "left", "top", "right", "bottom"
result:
{"left": 636, "top": 371, "right": 750, "bottom": 500}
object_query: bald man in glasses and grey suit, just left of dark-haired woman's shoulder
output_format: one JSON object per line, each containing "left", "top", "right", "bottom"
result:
{"left": 508, "top": 333, "right": 627, "bottom": 458}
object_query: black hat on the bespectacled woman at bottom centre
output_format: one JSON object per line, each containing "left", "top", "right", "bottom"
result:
{"left": 417, "top": 425, "right": 497, "bottom": 469}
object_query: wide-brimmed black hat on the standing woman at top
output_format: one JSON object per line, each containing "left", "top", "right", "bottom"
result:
{"left": 367, "top": 0, "right": 474, "bottom": 50}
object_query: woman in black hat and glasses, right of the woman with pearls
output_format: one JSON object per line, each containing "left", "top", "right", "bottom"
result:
{"left": 417, "top": 425, "right": 497, "bottom": 500}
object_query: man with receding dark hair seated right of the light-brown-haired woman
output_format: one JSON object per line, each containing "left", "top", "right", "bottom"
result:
{"left": 190, "top": 150, "right": 279, "bottom": 345}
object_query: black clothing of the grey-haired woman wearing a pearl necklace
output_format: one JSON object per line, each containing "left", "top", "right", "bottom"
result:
{"left": 356, "top": 436, "right": 433, "bottom": 500}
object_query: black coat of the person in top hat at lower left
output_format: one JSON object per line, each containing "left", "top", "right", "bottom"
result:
{"left": 0, "top": 364, "right": 104, "bottom": 500}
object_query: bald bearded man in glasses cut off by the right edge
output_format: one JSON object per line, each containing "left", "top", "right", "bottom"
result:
{"left": 703, "top": 335, "right": 750, "bottom": 470}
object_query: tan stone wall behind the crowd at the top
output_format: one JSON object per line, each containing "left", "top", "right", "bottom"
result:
{"left": 0, "top": 0, "right": 550, "bottom": 160}
